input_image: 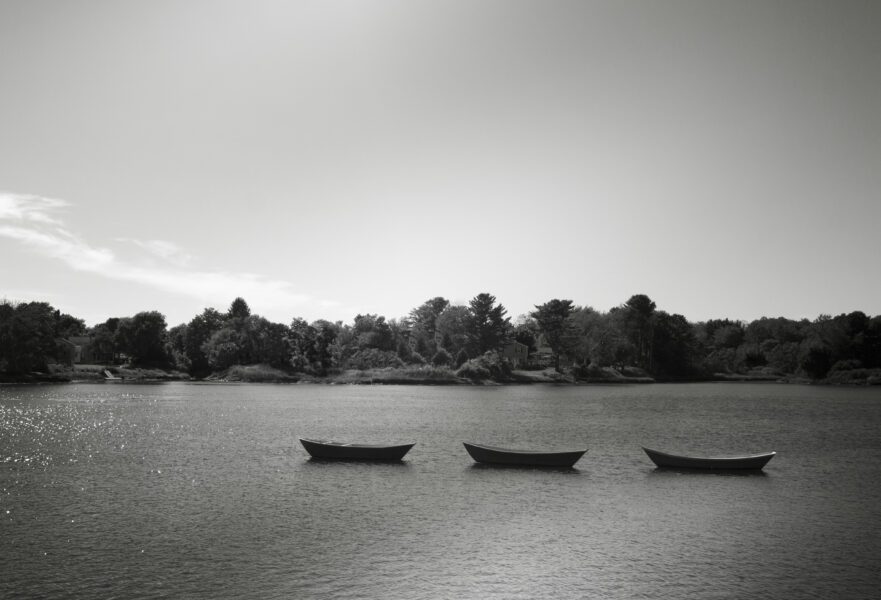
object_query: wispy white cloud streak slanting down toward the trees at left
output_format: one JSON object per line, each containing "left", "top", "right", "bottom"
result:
{"left": 0, "top": 192, "right": 316, "bottom": 308}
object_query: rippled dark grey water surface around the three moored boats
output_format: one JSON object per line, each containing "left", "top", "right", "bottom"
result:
{"left": 0, "top": 384, "right": 881, "bottom": 599}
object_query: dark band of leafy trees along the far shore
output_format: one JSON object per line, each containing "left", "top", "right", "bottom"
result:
{"left": 0, "top": 293, "right": 881, "bottom": 380}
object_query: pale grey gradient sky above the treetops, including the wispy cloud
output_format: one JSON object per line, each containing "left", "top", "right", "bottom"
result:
{"left": 0, "top": 0, "right": 881, "bottom": 326}
